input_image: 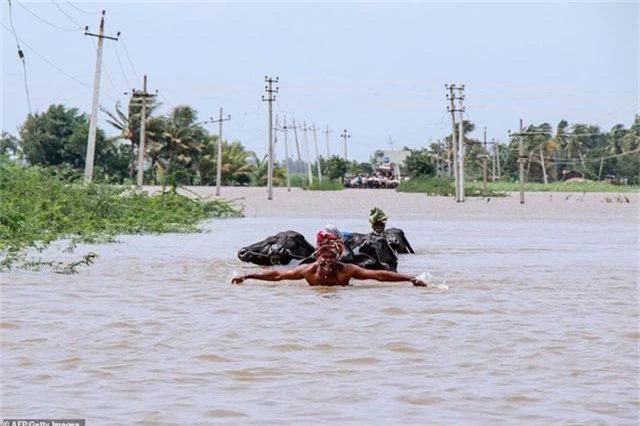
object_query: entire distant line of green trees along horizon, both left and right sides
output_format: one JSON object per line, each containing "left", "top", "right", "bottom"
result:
{"left": 0, "top": 97, "right": 640, "bottom": 186}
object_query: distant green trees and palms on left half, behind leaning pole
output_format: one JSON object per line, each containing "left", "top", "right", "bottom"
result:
{"left": 0, "top": 98, "right": 372, "bottom": 186}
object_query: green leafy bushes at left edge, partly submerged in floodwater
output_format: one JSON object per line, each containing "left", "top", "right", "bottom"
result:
{"left": 0, "top": 158, "right": 240, "bottom": 272}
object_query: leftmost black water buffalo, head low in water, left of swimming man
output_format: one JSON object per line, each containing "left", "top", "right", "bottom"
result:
{"left": 238, "top": 231, "right": 315, "bottom": 266}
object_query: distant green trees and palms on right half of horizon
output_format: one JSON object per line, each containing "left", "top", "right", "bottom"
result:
{"left": 402, "top": 115, "right": 640, "bottom": 185}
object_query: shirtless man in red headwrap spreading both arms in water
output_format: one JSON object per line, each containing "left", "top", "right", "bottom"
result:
{"left": 231, "top": 230, "right": 427, "bottom": 287}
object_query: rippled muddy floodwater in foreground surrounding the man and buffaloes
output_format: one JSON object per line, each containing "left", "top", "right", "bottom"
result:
{"left": 0, "top": 203, "right": 640, "bottom": 425}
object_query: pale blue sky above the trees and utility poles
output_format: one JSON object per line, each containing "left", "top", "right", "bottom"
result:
{"left": 0, "top": 0, "right": 639, "bottom": 161}
